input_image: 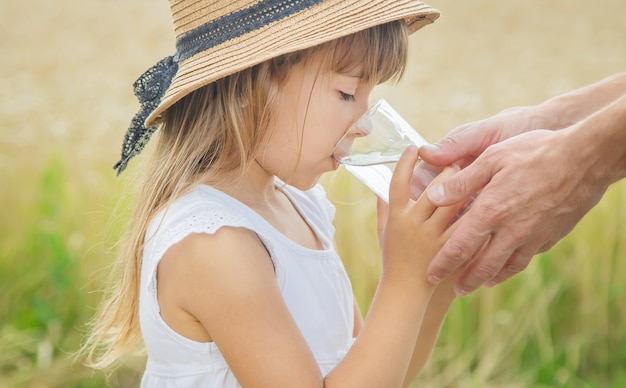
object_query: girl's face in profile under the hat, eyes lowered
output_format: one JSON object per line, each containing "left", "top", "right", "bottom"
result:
{"left": 257, "top": 57, "right": 373, "bottom": 190}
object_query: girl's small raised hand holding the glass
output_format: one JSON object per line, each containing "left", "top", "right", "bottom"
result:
{"left": 378, "top": 146, "right": 462, "bottom": 280}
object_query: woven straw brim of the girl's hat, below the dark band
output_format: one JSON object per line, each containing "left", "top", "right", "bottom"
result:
{"left": 146, "top": 0, "right": 439, "bottom": 127}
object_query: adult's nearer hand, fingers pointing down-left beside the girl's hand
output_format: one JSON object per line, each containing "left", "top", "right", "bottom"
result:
{"left": 421, "top": 124, "right": 604, "bottom": 295}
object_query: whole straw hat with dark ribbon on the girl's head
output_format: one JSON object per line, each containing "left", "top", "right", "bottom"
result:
{"left": 114, "top": 0, "right": 439, "bottom": 173}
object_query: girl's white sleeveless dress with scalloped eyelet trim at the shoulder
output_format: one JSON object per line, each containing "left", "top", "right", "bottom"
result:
{"left": 139, "top": 182, "right": 354, "bottom": 388}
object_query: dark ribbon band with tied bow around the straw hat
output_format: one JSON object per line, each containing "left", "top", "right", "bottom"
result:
{"left": 113, "top": 0, "right": 323, "bottom": 175}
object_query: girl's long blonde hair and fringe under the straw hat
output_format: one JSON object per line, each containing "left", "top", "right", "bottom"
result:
{"left": 77, "top": 21, "right": 408, "bottom": 369}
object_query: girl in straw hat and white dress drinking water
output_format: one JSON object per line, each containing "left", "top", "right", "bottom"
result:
{"left": 83, "top": 0, "right": 458, "bottom": 387}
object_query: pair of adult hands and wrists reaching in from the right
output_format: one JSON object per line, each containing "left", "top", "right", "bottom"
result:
{"left": 412, "top": 73, "right": 626, "bottom": 295}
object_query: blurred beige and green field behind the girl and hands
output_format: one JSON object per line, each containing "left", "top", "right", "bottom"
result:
{"left": 0, "top": 0, "right": 626, "bottom": 387}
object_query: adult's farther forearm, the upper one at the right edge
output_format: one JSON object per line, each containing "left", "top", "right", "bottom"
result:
{"left": 536, "top": 72, "right": 626, "bottom": 129}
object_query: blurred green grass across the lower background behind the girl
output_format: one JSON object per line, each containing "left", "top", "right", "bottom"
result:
{"left": 0, "top": 156, "right": 626, "bottom": 387}
